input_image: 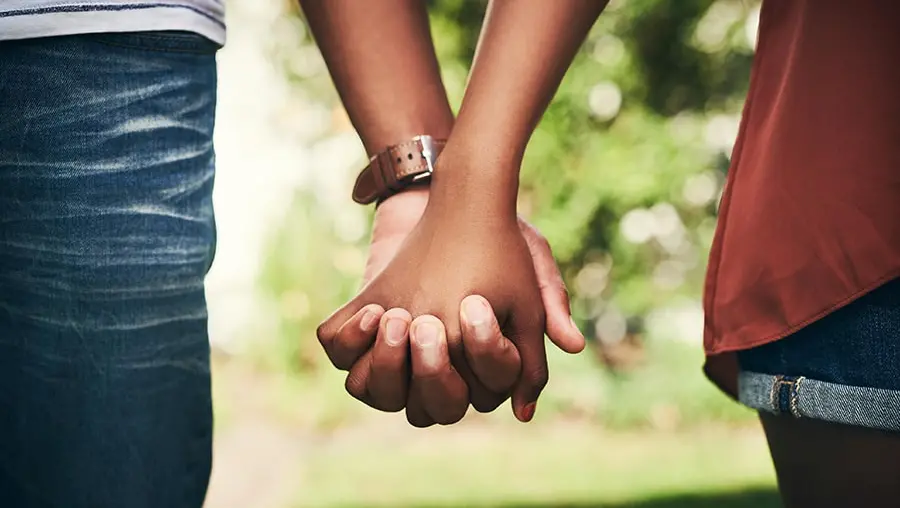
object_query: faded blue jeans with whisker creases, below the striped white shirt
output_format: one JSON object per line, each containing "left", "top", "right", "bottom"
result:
{"left": 0, "top": 32, "right": 218, "bottom": 508}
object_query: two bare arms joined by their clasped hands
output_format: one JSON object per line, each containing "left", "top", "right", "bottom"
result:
{"left": 301, "top": 0, "right": 606, "bottom": 427}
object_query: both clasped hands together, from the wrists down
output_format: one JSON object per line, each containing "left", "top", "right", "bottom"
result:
{"left": 317, "top": 189, "right": 584, "bottom": 427}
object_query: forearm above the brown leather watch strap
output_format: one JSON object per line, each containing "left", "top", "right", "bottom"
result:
{"left": 300, "top": 0, "right": 453, "bottom": 155}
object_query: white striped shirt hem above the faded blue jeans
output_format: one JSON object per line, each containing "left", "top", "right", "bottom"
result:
{"left": 0, "top": 0, "right": 225, "bottom": 44}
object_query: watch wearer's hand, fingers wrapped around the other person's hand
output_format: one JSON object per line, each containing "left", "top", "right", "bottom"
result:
{"left": 319, "top": 189, "right": 584, "bottom": 426}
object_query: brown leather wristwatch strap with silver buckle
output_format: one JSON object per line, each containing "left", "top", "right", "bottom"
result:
{"left": 353, "top": 134, "right": 446, "bottom": 205}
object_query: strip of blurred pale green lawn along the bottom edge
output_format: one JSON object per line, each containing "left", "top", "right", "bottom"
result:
{"left": 294, "top": 418, "right": 780, "bottom": 508}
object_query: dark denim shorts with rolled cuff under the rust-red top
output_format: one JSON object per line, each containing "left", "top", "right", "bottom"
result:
{"left": 738, "top": 279, "right": 900, "bottom": 432}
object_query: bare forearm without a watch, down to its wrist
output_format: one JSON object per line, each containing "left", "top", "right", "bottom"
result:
{"left": 434, "top": 0, "right": 607, "bottom": 210}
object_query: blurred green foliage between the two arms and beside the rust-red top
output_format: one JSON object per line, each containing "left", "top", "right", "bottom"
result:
{"left": 422, "top": 0, "right": 754, "bottom": 341}
